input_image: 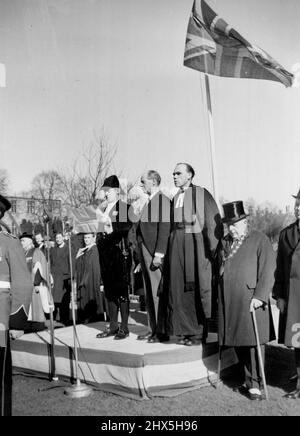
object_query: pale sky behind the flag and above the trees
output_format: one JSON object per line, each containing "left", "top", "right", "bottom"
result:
{"left": 0, "top": 0, "right": 300, "bottom": 207}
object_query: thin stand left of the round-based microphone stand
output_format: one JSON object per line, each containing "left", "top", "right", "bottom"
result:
{"left": 44, "top": 218, "right": 58, "bottom": 381}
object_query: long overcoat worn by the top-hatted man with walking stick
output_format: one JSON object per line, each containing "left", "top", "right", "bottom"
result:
{"left": 218, "top": 230, "right": 275, "bottom": 347}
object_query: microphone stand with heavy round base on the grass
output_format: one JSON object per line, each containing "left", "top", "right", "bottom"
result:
{"left": 64, "top": 233, "right": 93, "bottom": 398}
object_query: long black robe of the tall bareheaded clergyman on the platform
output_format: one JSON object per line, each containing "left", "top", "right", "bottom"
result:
{"left": 162, "top": 185, "right": 223, "bottom": 336}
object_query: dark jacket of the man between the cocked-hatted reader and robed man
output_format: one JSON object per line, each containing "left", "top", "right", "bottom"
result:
{"left": 137, "top": 191, "right": 171, "bottom": 256}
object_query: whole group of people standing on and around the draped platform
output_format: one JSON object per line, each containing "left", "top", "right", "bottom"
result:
{"left": 0, "top": 163, "right": 300, "bottom": 414}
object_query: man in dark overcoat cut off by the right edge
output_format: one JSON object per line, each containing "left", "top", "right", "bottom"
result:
{"left": 273, "top": 190, "right": 300, "bottom": 399}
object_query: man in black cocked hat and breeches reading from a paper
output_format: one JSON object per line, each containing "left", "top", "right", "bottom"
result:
{"left": 97, "top": 175, "right": 132, "bottom": 340}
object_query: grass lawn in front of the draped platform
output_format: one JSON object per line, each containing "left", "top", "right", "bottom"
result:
{"left": 13, "top": 344, "right": 300, "bottom": 416}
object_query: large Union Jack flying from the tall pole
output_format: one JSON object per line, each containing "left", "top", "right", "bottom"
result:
{"left": 184, "top": 0, "right": 294, "bottom": 87}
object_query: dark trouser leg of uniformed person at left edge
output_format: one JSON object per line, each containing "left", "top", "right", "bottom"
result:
{"left": 0, "top": 333, "right": 12, "bottom": 416}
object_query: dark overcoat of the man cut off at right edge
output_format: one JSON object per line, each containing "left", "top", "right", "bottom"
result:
{"left": 273, "top": 221, "right": 300, "bottom": 347}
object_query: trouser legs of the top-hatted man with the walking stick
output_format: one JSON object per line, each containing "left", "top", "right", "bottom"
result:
{"left": 235, "top": 345, "right": 265, "bottom": 389}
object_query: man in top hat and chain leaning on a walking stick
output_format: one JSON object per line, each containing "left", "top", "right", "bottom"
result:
{"left": 218, "top": 201, "right": 275, "bottom": 400}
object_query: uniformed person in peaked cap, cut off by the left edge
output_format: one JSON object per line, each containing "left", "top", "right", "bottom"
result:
{"left": 0, "top": 195, "right": 32, "bottom": 416}
